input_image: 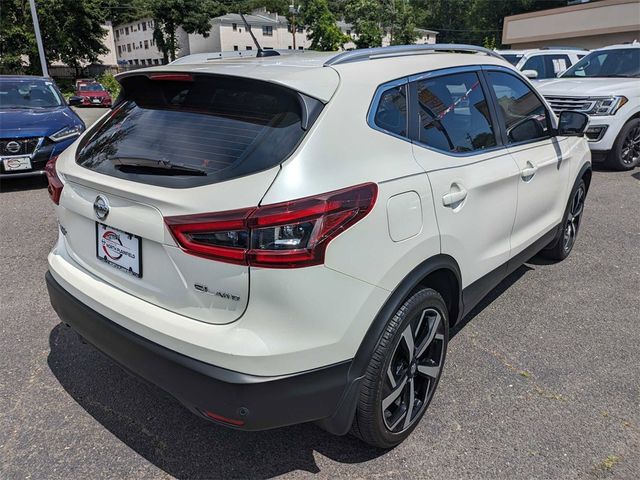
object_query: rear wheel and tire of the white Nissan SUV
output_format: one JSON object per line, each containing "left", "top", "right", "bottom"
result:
{"left": 351, "top": 288, "right": 449, "bottom": 448}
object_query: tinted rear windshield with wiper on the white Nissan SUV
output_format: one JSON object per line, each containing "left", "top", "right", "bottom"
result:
{"left": 77, "top": 74, "right": 316, "bottom": 188}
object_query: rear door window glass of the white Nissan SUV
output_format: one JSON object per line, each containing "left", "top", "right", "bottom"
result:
{"left": 416, "top": 73, "right": 496, "bottom": 153}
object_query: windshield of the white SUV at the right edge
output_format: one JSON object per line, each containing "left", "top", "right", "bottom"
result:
{"left": 562, "top": 48, "right": 640, "bottom": 78}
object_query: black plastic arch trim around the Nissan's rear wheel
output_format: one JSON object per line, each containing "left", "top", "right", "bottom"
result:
{"left": 317, "top": 254, "right": 464, "bottom": 435}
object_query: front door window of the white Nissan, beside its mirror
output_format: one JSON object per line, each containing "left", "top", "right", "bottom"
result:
{"left": 487, "top": 72, "right": 551, "bottom": 143}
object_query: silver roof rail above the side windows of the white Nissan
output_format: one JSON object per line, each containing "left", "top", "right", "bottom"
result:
{"left": 324, "top": 43, "right": 502, "bottom": 67}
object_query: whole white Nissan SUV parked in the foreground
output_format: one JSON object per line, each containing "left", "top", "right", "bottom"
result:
{"left": 47, "top": 45, "right": 591, "bottom": 447}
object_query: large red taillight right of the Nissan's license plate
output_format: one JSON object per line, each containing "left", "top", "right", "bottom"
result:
{"left": 165, "top": 183, "right": 378, "bottom": 268}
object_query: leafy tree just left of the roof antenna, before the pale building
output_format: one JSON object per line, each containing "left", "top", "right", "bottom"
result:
{"left": 147, "top": 0, "right": 224, "bottom": 63}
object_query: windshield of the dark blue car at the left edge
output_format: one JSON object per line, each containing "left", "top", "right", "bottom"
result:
{"left": 0, "top": 78, "right": 64, "bottom": 109}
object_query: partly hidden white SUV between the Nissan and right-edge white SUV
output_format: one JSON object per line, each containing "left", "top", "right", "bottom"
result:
{"left": 496, "top": 47, "right": 589, "bottom": 80}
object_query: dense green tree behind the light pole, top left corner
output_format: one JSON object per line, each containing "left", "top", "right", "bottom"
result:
{"left": 0, "top": 0, "right": 107, "bottom": 74}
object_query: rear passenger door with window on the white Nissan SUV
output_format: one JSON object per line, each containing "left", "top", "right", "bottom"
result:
{"left": 412, "top": 71, "right": 519, "bottom": 288}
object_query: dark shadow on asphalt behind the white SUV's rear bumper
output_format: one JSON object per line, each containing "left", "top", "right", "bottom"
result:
{"left": 48, "top": 324, "right": 385, "bottom": 479}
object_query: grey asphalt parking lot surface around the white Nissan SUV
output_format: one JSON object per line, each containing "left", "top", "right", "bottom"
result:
{"left": 0, "top": 110, "right": 640, "bottom": 479}
